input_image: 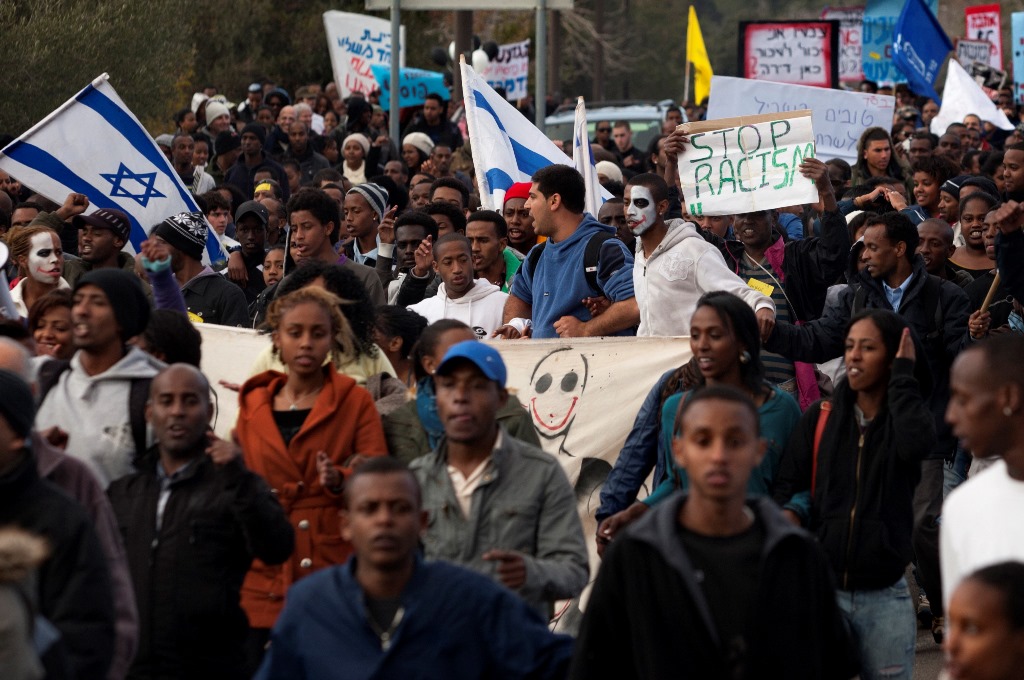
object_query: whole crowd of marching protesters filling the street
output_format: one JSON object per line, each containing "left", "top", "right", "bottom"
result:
{"left": 0, "top": 71, "right": 1024, "bottom": 680}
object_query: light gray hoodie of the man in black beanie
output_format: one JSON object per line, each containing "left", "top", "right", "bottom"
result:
{"left": 36, "top": 347, "right": 164, "bottom": 488}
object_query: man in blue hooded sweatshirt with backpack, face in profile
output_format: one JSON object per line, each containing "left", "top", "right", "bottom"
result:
{"left": 495, "top": 165, "right": 640, "bottom": 339}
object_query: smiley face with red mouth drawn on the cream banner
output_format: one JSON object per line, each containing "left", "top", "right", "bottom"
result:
{"left": 526, "top": 347, "right": 588, "bottom": 456}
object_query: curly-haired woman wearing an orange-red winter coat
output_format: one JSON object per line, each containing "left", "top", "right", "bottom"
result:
{"left": 236, "top": 286, "right": 387, "bottom": 662}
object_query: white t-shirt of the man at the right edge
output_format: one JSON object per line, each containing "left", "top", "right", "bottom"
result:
{"left": 939, "top": 459, "right": 1024, "bottom": 607}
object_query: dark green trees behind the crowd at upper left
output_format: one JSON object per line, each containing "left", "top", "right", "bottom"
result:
{"left": 0, "top": 0, "right": 436, "bottom": 135}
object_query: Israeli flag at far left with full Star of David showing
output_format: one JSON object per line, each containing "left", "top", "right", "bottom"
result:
{"left": 0, "top": 74, "right": 227, "bottom": 264}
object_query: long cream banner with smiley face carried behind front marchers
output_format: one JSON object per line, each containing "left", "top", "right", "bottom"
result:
{"left": 196, "top": 324, "right": 691, "bottom": 632}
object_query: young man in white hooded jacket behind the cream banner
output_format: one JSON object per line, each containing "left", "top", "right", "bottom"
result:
{"left": 409, "top": 233, "right": 505, "bottom": 339}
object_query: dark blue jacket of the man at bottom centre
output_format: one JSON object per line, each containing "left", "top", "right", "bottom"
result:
{"left": 256, "top": 557, "right": 572, "bottom": 680}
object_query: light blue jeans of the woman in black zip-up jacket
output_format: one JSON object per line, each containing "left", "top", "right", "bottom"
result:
{"left": 837, "top": 577, "right": 918, "bottom": 680}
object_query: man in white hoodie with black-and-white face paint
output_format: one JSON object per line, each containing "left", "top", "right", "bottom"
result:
{"left": 623, "top": 173, "right": 775, "bottom": 336}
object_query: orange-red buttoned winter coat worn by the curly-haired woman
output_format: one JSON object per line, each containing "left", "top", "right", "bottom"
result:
{"left": 237, "top": 366, "right": 387, "bottom": 628}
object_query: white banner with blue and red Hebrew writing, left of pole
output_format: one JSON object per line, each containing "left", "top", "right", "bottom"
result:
{"left": 324, "top": 10, "right": 406, "bottom": 97}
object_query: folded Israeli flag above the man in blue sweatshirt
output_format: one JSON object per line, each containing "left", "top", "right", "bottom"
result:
{"left": 462, "top": 63, "right": 572, "bottom": 210}
